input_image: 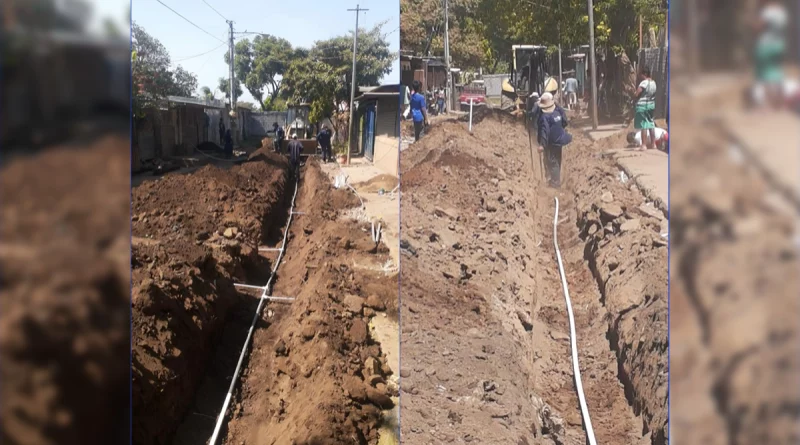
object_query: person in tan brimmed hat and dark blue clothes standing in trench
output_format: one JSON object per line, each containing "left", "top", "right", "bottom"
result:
{"left": 537, "top": 93, "right": 572, "bottom": 188}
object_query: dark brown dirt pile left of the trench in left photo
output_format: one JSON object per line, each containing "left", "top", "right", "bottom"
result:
{"left": 131, "top": 147, "right": 288, "bottom": 444}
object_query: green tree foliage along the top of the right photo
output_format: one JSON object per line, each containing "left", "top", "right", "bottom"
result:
{"left": 400, "top": 0, "right": 667, "bottom": 72}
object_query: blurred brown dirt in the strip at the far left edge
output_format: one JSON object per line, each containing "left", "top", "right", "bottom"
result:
{"left": 0, "top": 137, "right": 130, "bottom": 445}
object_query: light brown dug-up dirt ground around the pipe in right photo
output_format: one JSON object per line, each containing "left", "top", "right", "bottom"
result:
{"left": 401, "top": 112, "right": 667, "bottom": 444}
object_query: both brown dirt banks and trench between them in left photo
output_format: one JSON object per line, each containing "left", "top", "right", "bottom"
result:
{"left": 131, "top": 153, "right": 404, "bottom": 444}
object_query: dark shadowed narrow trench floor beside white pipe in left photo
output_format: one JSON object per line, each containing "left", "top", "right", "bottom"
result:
{"left": 172, "top": 171, "right": 302, "bottom": 445}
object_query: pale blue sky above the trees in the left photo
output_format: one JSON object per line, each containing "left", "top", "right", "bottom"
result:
{"left": 134, "top": 0, "right": 400, "bottom": 102}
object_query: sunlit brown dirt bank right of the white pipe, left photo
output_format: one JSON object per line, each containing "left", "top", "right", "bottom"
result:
{"left": 226, "top": 161, "right": 397, "bottom": 445}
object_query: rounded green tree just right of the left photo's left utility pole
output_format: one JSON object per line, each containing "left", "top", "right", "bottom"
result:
{"left": 224, "top": 34, "right": 296, "bottom": 110}
